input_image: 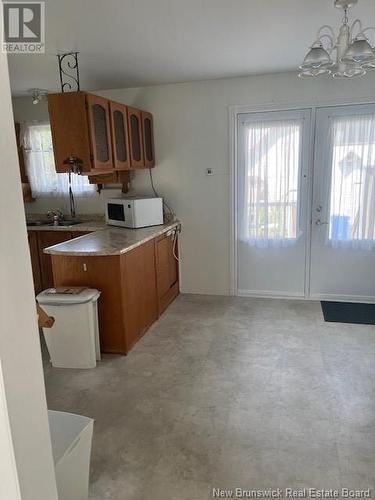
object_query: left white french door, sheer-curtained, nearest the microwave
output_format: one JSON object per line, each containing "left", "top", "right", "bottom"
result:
{"left": 237, "top": 109, "right": 311, "bottom": 297}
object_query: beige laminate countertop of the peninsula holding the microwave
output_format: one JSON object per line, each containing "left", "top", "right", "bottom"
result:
{"left": 44, "top": 221, "right": 180, "bottom": 256}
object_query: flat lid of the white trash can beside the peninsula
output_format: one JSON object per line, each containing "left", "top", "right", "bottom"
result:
{"left": 36, "top": 287, "right": 100, "bottom": 306}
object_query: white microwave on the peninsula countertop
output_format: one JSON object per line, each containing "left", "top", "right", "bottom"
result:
{"left": 105, "top": 197, "right": 163, "bottom": 229}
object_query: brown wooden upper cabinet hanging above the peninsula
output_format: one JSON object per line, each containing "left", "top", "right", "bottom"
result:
{"left": 48, "top": 92, "right": 155, "bottom": 176}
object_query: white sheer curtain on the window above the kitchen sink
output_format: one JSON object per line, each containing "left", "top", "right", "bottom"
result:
{"left": 21, "top": 123, "right": 96, "bottom": 198}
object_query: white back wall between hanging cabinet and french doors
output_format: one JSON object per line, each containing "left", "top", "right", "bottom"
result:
{"left": 15, "top": 73, "right": 375, "bottom": 294}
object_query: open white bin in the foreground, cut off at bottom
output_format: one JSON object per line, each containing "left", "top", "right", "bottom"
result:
{"left": 48, "top": 410, "right": 94, "bottom": 500}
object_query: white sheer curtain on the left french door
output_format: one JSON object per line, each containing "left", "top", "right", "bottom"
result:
{"left": 238, "top": 119, "right": 302, "bottom": 247}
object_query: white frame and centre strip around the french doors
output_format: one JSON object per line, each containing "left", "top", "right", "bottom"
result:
{"left": 228, "top": 97, "right": 375, "bottom": 302}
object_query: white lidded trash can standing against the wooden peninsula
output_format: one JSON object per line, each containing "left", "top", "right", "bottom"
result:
{"left": 36, "top": 287, "right": 100, "bottom": 368}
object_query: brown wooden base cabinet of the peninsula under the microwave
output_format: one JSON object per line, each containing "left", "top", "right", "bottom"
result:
{"left": 51, "top": 232, "right": 178, "bottom": 354}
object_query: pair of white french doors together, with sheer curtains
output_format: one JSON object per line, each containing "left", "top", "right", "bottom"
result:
{"left": 236, "top": 105, "right": 375, "bottom": 302}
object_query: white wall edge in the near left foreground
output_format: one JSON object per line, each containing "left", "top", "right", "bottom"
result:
{"left": 0, "top": 51, "right": 57, "bottom": 500}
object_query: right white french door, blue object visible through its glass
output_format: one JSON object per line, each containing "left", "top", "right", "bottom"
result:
{"left": 310, "top": 105, "right": 375, "bottom": 302}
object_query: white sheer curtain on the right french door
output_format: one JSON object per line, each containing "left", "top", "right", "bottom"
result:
{"left": 328, "top": 115, "right": 375, "bottom": 249}
